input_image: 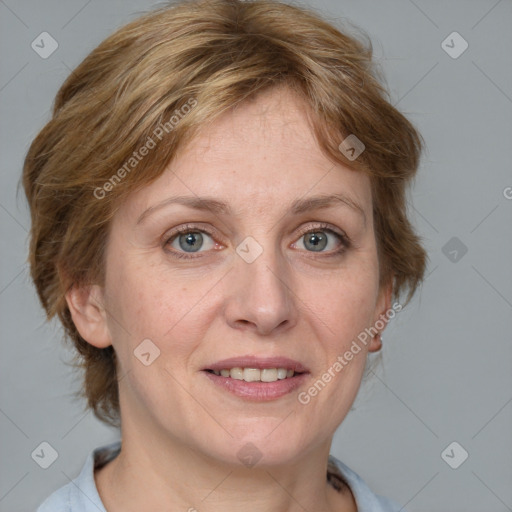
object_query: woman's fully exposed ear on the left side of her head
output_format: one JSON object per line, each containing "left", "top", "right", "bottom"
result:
{"left": 66, "top": 285, "right": 112, "bottom": 348}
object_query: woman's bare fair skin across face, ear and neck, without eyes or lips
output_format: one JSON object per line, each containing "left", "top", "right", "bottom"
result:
{"left": 67, "top": 88, "right": 391, "bottom": 512}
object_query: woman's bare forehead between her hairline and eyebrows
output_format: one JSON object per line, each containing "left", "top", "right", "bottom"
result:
{"left": 119, "top": 88, "right": 371, "bottom": 222}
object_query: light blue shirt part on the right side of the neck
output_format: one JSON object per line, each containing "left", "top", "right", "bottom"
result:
{"left": 329, "top": 455, "right": 406, "bottom": 512}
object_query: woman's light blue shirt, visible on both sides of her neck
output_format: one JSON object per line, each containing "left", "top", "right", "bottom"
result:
{"left": 36, "top": 441, "right": 404, "bottom": 512}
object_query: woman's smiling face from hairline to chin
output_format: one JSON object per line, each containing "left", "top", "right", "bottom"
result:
{"left": 92, "top": 89, "right": 389, "bottom": 464}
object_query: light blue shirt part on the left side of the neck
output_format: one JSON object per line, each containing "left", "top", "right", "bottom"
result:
{"left": 36, "top": 441, "right": 121, "bottom": 512}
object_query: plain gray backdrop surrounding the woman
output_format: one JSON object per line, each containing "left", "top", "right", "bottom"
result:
{"left": 0, "top": 0, "right": 512, "bottom": 512}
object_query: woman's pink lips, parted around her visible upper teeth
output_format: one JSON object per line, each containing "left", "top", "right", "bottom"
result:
{"left": 201, "top": 356, "right": 310, "bottom": 402}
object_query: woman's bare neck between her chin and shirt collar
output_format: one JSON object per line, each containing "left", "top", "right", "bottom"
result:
{"left": 95, "top": 418, "right": 357, "bottom": 512}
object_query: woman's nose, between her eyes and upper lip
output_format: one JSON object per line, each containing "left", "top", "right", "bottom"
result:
{"left": 224, "top": 240, "right": 298, "bottom": 336}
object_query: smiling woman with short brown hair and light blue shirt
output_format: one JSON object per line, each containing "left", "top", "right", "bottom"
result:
{"left": 23, "top": 0, "right": 426, "bottom": 512}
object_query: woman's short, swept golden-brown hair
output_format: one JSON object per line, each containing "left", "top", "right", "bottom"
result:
{"left": 23, "top": 0, "right": 427, "bottom": 425}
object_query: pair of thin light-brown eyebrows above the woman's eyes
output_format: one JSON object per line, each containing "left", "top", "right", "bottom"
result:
{"left": 137, "top": 194, "right": 366, "bottom": 226}
